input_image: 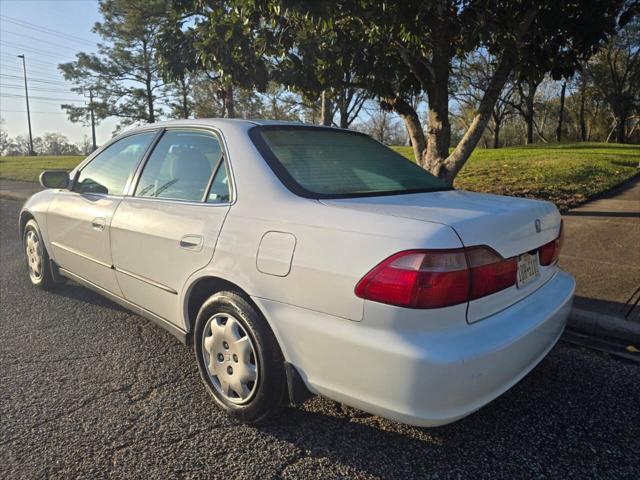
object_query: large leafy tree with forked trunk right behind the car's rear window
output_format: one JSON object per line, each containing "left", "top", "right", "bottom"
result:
{"left": 264, "top": 0, "right": 622, "bottom": 182}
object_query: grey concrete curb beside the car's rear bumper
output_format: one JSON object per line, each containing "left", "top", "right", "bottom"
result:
{"left": 568, "top": 307, "right": 640, "bottom": 348}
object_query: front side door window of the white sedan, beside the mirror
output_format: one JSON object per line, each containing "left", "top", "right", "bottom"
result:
{"left": 74, "top": 131, "right": 156, "bottom": 195}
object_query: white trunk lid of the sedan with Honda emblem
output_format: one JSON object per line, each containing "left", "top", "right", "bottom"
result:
{"left": 322, "top": 190, "right": 560, "bottom": 322}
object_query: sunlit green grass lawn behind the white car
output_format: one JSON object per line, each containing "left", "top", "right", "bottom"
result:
{"left": 0, "top": 143, "right": 640, "bottom": 209}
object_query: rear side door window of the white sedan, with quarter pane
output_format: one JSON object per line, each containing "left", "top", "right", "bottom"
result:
{"left": 135, "top": 130, "right": 222, "bottom": 202}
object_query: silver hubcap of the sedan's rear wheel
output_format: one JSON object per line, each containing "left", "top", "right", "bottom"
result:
{"left": 202, "top": 313, "right": 258, "bottom": 404}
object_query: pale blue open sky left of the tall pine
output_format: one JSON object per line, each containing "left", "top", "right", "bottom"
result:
{"left": 0, "top": 0, "right": 117, "bottom": 145}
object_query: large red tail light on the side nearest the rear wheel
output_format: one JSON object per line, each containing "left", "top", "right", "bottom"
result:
{"left": 355, "top": 246, "right": 517, "bottom": 308}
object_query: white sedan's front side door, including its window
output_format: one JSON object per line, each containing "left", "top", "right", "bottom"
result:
{"left": 47, "top": 130, "right": 157, "bottom": 295}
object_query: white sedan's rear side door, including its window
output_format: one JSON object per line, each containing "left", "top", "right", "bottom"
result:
{"left": 111, "top": 128, "right": 232, "bottom": 329}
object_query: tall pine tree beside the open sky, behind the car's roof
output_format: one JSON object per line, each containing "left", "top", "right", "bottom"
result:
{"left": 59, "top": 0, "right": 166, "bottom": 129}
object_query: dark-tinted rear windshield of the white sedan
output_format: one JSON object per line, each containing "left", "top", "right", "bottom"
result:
{"left": 250, "top": 126, "right": 450, "bottom": 198}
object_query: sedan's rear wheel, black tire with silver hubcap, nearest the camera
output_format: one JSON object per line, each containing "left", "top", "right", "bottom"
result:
{"left": 193, "top": 292, "right": 287, "bottom": 423}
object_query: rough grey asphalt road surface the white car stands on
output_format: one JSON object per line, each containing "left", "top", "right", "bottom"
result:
{"left": 0, "top": 200, "right": 640, "bottom": 479}
